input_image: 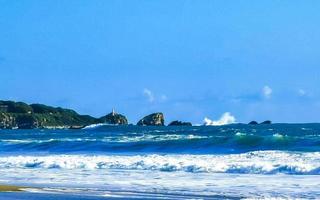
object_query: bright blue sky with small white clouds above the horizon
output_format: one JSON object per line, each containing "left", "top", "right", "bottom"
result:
{"left": 0, "top": 0, "right": 320, "bottom": 123}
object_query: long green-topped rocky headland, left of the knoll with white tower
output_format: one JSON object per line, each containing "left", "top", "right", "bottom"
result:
{"left": 0, "top": 101, "right": 99, "bottom": 129}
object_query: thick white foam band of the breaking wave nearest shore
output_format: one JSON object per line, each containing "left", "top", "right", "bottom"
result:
{"left": 0, "top": 151, "right": 320, "bottom": 175}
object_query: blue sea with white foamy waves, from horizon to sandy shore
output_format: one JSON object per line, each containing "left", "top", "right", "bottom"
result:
{"left": 0, "top": 124, "right": 320, "bottom": 199}
